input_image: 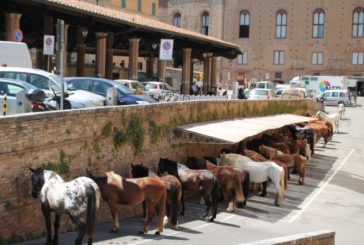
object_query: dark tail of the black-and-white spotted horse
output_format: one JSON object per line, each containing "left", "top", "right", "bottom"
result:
{"left": 86, "top": 185, "right": 100, "bottom": 238}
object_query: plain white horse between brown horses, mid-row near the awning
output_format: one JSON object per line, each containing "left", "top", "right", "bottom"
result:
{"left": 220, "top": 153, "right": 284, "bottom": 206}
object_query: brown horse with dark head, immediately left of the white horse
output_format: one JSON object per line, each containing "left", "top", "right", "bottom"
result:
{"left": 186, "top": 157, "right": 250, "bottom": 212}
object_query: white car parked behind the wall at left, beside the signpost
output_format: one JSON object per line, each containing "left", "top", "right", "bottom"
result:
{"left": 0, "top": 67, "right": 106, "bottom": 109}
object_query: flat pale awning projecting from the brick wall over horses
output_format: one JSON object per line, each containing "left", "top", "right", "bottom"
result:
{"left": 177, "top": 114, "right": 316, "bottom": 144}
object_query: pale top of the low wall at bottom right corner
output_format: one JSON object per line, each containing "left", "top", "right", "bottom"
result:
{"left": 240, "top": 230, "right": 335, "bottom": 245}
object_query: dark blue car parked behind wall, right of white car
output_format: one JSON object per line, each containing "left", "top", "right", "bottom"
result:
{"left": 65, "top": 77, "right": 157, "bottom": 105}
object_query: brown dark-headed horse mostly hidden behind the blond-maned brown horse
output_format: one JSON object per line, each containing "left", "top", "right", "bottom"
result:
{"left": 131, "top": 164, "right": 182, "bottom": 230}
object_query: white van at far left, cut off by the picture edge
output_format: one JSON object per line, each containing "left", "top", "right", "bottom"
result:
{"left": 0, "top": 41, "right": 32, "bottom": 68}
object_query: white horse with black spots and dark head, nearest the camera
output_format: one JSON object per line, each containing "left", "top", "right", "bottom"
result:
{"left": 29, "top": 168, "right": 100, "bottom": 245}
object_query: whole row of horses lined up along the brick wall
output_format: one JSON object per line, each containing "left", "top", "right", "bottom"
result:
{"left": 30, "top": 112, "right": 340, "bottom": 244}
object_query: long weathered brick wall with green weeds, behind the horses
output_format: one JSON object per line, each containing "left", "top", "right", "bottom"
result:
{"left": 0, "top": 100, "right": 320, "bottom": 238}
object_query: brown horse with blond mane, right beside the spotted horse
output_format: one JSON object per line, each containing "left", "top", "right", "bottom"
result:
{"left": 87, "top": 171, "right": 166, "bottom": 235}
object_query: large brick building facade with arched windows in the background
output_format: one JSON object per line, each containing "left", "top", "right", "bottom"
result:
{"left": 159, "top": 0, "right": 364, "bottom": 82}
